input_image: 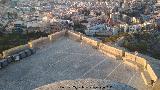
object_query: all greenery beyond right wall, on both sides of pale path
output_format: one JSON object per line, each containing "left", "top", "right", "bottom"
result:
{"left": 103, "top": 32, "right": 160, "bottom": 59}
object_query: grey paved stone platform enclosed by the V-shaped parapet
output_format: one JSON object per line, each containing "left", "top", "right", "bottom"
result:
{"left": 0, "top": 38, "right": 148, "bottom": 90}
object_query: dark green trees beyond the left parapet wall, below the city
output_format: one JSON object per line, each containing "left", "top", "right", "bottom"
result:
{"left": 0, "top": 32, "right": 47, "bottom": 52}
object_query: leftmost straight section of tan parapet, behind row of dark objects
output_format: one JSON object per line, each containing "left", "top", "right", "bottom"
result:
{"left": 2, "top": 44, "right": 29, "bottom": 58}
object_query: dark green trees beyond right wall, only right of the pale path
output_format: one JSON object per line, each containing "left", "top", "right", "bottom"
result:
{"left": 122, "top": 32, "right": 160, "bottom": 59}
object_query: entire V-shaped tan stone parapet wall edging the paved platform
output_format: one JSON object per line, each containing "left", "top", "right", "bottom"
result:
{"left": 3, "top": 30, "right": 160, "bottom": 89}
